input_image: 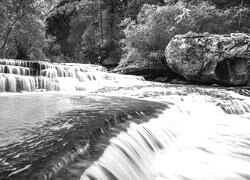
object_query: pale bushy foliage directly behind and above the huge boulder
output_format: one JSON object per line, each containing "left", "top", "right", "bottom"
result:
{"left": 122, "top": 1, "right": 250, "bottom": 65}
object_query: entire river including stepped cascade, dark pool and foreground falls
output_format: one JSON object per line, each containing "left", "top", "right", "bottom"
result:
{"left": 0, "top": 60, "right": 250, "bottom": 180}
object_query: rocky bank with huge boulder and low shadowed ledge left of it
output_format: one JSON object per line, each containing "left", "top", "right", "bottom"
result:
{"left": 114, "top": 32, "right": 250, "bottom": 86}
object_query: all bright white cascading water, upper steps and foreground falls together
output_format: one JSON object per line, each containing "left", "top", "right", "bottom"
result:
{"left": 0, "top": 60, "right": 250, "bottom": 180}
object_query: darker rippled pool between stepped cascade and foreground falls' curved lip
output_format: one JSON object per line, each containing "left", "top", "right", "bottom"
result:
{"left": 0, "top": 93, "right": 167, "bottom": 180}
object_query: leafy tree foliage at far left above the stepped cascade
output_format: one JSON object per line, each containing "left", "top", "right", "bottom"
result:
{"left": 0, "top": 0, "right": 53, "bottom": 60}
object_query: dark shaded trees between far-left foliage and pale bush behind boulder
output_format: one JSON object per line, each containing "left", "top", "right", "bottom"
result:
{"left": 47, "top": 0, "right": 169, "bottom": 63}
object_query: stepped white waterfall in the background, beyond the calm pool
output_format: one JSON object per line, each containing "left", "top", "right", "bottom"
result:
{"left": 0, "top": 59, "right": 144, "bottom": 92}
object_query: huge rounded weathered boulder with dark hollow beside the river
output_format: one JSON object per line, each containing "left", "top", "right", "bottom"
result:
{"left": 165, "top": 32, "right": 250, "bottom": 85}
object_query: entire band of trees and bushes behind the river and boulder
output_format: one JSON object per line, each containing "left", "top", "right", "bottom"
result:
{"left": 0, "top": 0, "right": 250, "bottom": 65}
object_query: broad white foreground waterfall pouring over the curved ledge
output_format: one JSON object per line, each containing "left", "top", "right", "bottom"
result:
{"left": 81, "top": 96, "right": 250, "bottom": 180}
